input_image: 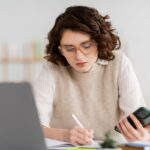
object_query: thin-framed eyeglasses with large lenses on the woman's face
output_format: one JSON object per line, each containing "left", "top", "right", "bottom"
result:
{"left": 59, "top": 40, "right": 96, "bottom": 58}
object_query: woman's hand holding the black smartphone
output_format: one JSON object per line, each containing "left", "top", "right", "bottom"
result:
{"left": 118, "top": 114, "right": 150, "bottom": 142}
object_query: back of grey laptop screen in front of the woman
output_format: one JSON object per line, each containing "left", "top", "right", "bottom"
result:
{"left": 0, "top": 83, "right": 46, "bottom": 150}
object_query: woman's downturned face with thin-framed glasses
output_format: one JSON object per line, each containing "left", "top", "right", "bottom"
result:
{"left": 59, "top": 30, "right": 98, "bottom": 72}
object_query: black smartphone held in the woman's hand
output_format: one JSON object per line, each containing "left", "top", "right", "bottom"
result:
{"left": 115, "top": 107, "right": 150, "bottom": 132}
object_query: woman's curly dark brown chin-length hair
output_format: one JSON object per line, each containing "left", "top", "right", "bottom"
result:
{"left": 45, "top": 6, "right": 121, "bottom": 65}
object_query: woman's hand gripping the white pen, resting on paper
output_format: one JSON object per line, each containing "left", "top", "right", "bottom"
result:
{"left": 70, "top": 126, "right": 93, "bottom": 145}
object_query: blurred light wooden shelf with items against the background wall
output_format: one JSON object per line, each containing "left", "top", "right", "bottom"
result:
{"left": 0, "top": 41, "right": 45, "bottom": 82}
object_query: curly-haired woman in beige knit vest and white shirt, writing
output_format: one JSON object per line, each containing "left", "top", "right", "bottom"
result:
{"left": 34, "top": 6, "right": 145, "bottom": 144}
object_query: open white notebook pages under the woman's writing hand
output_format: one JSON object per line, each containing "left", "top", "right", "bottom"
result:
{"left": 45, "top": 138, "right": 100, "bottom": 150}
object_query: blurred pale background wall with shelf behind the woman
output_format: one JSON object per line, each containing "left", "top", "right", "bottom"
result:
{"left": 0, "top": 0, "right": 150, "bottom": 106}
